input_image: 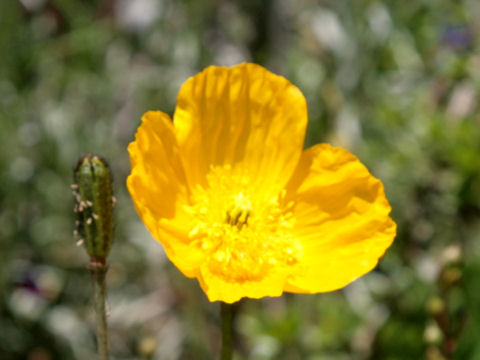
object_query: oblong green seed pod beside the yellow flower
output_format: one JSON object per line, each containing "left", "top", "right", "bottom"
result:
{"left": 72, "top": 154, "right": 114, "bottom": 262}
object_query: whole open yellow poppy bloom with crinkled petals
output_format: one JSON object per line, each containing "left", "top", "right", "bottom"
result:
{"left": 127, "top": 64, "right": 396, "bottom": 303}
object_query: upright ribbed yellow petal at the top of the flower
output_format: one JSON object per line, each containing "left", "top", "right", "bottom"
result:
{"left": 174, "top": 63, "right": 307, "bottom": 193}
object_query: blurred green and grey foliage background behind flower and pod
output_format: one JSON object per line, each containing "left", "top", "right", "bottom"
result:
{"left": 0, "top": 0, "right": 480, "bottom": 360}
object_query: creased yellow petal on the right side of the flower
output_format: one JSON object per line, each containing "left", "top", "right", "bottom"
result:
{"left": 285, "top": 144, "right": 396, "bottom": 293}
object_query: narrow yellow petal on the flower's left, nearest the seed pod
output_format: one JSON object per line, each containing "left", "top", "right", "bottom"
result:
{"left": 127, "top": 111, "right": 203, "bottom": 277}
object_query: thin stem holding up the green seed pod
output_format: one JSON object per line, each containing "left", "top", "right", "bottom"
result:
{"left": 88, "top": 259, "right": 109, "bottom": 360}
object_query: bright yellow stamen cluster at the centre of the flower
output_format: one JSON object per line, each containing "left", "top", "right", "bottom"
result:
{"left": 187, "top": 166, "right": 300, "bottom": 281}
